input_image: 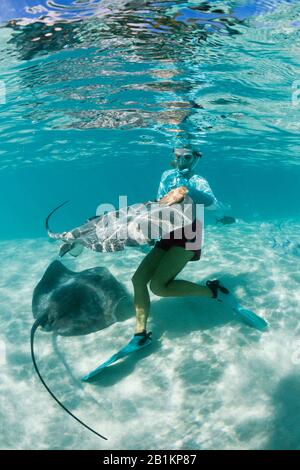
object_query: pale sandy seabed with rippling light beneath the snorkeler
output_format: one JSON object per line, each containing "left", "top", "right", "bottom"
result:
{"left": 0, "top": 223, "right": 300, "bottom": 450}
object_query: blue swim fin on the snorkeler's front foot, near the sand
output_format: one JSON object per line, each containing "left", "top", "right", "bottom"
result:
{"left": 81, "top": 331, "right": 152, "bottom": 382}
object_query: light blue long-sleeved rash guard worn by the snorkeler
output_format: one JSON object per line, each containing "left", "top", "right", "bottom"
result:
{"left": 157, "top": 169, "right": 219, "bottom": 210}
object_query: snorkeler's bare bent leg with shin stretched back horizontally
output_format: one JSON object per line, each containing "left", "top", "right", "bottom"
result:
{"left": 150, "top": 246, "right": 212, "bottom": 297}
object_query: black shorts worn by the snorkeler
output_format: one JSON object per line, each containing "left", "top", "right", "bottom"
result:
{"left": 155, "top": 219, "right": 202, "bottom": 261}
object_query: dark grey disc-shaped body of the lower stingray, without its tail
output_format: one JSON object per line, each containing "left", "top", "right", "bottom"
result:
{"left": 32, "top": 261, "right": 131, "bottom": 336}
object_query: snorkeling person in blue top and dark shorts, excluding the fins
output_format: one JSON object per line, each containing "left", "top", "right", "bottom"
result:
{"left": 132, "top": 147, "right": 229, "bottom": 344}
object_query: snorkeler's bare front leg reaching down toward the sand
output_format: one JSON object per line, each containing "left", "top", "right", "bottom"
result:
{"left": 132, "top": 248, "right": 166, "bottom": 333}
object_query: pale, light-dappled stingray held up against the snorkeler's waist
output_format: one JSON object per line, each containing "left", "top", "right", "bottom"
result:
{"left": 46, "top": 196, "right": 194, "bottom": 256}
